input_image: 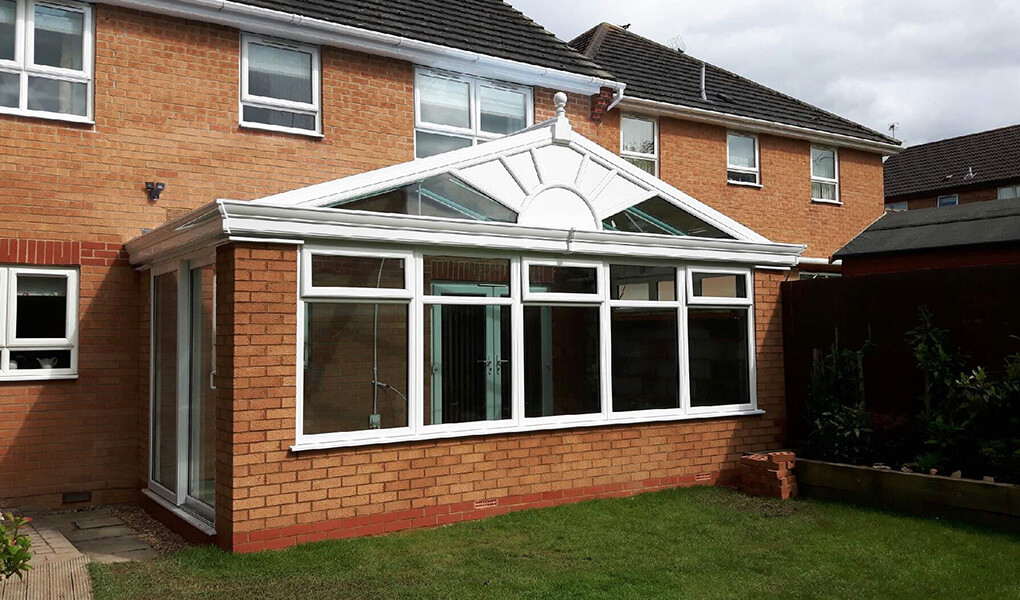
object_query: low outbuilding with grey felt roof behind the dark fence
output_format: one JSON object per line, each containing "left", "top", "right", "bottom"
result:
{"left": 832, "top": 198, "right": 1020, "bottom": 277}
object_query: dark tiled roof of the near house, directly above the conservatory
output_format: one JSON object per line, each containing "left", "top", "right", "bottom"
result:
{"left": 230, "top": 0, "right": 609, "bottom": 78}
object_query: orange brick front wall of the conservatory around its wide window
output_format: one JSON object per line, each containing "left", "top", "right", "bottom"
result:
{"left": 216, "top": 243, "right": 787, "bottom": 552}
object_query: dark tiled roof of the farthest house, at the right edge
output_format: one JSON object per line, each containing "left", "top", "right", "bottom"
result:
{"left": 884, "top": 124, "right": 1020, "bottom": 199}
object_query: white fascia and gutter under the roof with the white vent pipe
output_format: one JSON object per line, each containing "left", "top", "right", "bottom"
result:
{"left": 620, "top": 96, "right": 905, "bottom": 156}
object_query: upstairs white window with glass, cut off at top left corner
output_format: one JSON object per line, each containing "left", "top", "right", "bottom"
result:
{"left": 0, "top": 0, "right": 93, "bottom": 122}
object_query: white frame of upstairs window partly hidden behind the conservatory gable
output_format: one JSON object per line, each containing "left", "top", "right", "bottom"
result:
{"left": 414, "top": 66, "right": 534, "bottom": 157}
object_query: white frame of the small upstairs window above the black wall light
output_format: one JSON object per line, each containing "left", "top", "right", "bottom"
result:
{"left": 238, "top": 33, "right": 322, "bottom": 138}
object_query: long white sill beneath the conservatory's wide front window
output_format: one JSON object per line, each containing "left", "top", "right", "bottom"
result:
{"left": 291, "top": 408, "right": 765, "bottom": 452}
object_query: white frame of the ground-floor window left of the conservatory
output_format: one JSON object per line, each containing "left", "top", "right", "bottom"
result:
{"left": 0, "top": 266, "right": 79, "bottom": 382}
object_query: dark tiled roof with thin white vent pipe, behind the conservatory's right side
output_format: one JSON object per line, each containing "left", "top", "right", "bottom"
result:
{"left": 570, "top": 22, "right": 900, "bottom": 145}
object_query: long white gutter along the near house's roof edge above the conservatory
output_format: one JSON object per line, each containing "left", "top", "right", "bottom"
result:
{"left": 98, "top": 0, "right": 625, "bottom": 96}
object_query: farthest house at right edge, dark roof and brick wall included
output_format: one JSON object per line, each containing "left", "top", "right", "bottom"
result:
{"left": 885, "top": 124, "right": 1020, "bottom": 210}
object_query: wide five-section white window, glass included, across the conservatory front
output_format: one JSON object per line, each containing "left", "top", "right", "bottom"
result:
{"left": 295, "top": 246, "right": 756, "bottom": 449}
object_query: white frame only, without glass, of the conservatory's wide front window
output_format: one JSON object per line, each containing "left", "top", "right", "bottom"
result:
{"left": 292, "top": 244, "right": 763, "bottom": 451}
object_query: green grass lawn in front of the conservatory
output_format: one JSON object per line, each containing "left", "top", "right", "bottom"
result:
{"left": 91, "top": 488, "right": 1020, "bottom": 600}
